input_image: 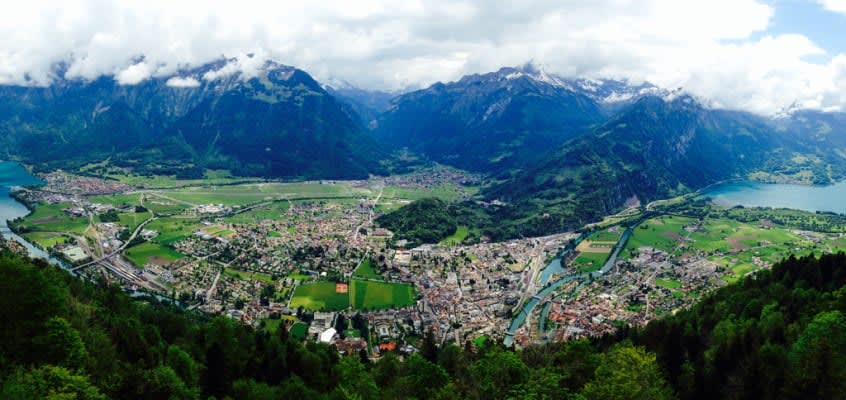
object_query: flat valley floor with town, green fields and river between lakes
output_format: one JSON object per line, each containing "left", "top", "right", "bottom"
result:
{"left": 6, "top": 170, "right": 846, "bottom": 355}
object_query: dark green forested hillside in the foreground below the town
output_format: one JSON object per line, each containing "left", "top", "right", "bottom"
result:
{"left": 0, "top": 248, "right": 846, "bottom": 400}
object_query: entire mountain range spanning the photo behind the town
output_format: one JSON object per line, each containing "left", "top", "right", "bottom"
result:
{"left": 0, "top": 60, "right": 846, "bottom": 238}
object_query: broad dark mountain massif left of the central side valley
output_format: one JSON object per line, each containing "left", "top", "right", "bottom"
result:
{"left": 0, "top": 60, "right": 383, "bottom": 178}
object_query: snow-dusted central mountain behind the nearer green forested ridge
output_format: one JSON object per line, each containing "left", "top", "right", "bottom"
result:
{"left": 374, "top": 66, "right": 603, "bottom": 172}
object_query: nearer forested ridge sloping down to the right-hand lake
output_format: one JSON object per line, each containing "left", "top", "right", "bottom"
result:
{"left": 470, "top": 96, "right": 846, "bottom": 237}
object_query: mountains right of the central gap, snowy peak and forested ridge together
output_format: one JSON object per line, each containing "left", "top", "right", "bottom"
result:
{"left": 374, "top": 65, "right": 846, "bottom": 239}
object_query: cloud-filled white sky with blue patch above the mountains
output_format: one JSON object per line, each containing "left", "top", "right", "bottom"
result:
{"left": 0, "top": 0, "right": 846, "bottom": 113}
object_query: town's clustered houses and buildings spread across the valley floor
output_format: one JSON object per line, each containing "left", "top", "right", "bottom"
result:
{"left": 21, "top": 169, "right": 800, "bottom": 356}
